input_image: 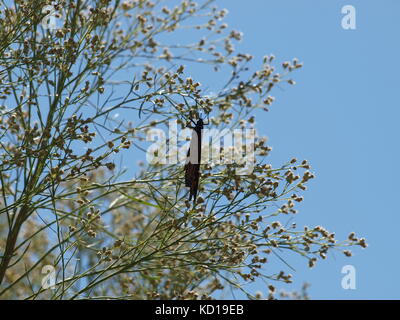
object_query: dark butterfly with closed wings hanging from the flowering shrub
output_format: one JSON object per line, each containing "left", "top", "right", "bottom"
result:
{"left": 185, "top": 118, "right": 208, "bottom": 206}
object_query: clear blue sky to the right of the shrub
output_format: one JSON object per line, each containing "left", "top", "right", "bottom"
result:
{"left": 196, "top": 0, "right": 400, "bottom": 299}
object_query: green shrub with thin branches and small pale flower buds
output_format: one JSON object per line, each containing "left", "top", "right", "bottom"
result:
{"left": 0, "top": 0, "right": 366, "bottom": 299}
